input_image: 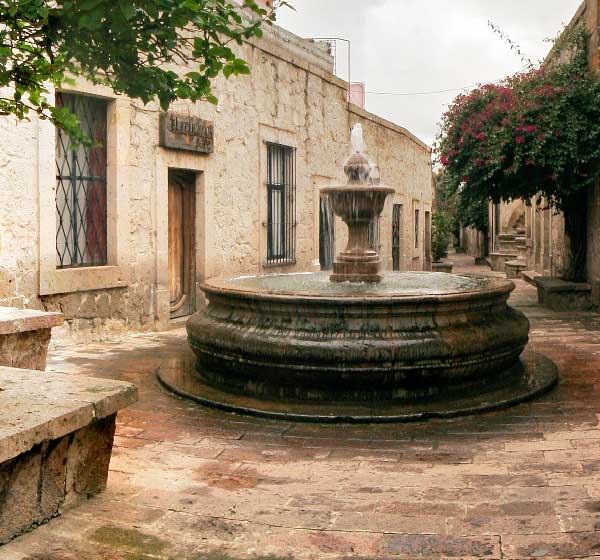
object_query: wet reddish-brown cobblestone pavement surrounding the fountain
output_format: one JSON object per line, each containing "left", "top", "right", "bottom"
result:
{"left": 0, "top": 257, "right": 600, "bottom": 560}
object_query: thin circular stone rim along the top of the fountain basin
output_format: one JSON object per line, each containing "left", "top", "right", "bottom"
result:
{"left": 200, "top": 272, "right": 515, "bottom": 305}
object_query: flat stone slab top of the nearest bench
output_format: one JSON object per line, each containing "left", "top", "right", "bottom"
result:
{"left": 0, "top": 367, "right": 137, "bottom": 463}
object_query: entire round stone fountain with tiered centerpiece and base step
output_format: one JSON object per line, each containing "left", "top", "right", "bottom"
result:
{"left": 159, "top": 124, "right": 557, "bottom": 422}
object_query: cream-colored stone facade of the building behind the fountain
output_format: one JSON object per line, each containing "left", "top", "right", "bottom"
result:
{"left": 0, "top": 21, "right": 433, "bottom": 337}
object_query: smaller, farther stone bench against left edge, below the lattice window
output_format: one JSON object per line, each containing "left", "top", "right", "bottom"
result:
{"left": 0, "top": 307, "right": 64, "bottom": 371}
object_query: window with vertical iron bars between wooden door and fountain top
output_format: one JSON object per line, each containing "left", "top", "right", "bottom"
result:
{"left": 267, "top": 144, "right": 296, "bottom": 264}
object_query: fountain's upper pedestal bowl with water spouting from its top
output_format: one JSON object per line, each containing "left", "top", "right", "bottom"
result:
{"left": 321, "top": 125, "right": 395, "bottom": 283}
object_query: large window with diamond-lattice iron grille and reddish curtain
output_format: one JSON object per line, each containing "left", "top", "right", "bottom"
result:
{"left": 56, "top": 93, "right": 108, "bottom": 268}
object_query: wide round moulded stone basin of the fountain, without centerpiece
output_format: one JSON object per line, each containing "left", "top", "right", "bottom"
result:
{"left": 187, "top": 272, "right": 529, "bottom": 403}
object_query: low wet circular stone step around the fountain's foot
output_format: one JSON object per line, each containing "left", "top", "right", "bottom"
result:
{"left": 156, "top": 350, "right": 559, "bottom": 424}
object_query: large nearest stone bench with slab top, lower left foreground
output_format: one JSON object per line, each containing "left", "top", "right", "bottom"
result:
{"left": 0, "top": 367, "right": 137, "bottom": 543}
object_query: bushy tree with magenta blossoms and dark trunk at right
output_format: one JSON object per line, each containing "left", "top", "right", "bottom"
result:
{"left": 439, "top": 28, "right": 600, "bottom": 280}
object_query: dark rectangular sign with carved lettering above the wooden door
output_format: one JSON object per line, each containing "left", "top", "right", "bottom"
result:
{"left": 160, "top": 111, "right": 215, "bottom": 154}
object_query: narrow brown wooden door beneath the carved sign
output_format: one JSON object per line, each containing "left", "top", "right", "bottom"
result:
{"left": 169, "top": 171, "right": 196, "bottom": 319}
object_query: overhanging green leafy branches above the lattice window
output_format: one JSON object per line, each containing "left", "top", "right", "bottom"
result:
{"left": 0, "top": 0, "right": 287, "bottom": 140}
